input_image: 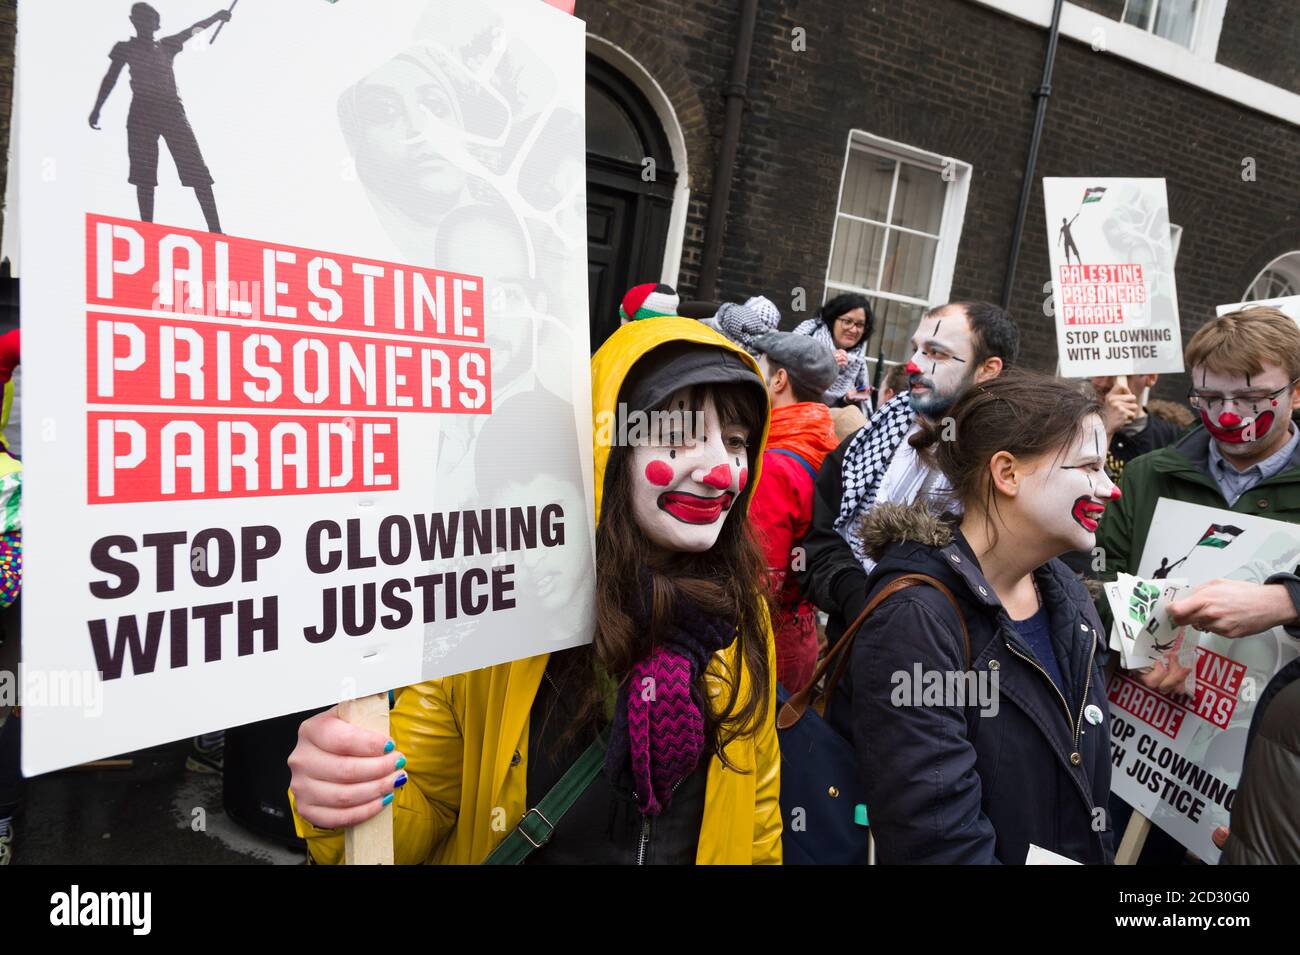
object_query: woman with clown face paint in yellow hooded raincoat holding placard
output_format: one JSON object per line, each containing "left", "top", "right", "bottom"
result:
{"left": 290, "top": 318, "right": 781, "bottom": 864}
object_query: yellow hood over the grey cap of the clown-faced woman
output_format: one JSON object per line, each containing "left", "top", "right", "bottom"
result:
{"left": 592, "top": 317, "right": 771, "bottom": 522}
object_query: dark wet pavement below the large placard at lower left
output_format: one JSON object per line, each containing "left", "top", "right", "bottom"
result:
{"left": 12, "top": 739, "right": 306, "bottom": 865}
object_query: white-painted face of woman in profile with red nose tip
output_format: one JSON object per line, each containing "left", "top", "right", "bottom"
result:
{"left": 1018, "top": 414, "right": 1119, "bottom": 551}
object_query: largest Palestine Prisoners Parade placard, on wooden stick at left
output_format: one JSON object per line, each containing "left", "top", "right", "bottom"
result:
{"left": 18, "top": 0, "right": 594, "bottom": 774}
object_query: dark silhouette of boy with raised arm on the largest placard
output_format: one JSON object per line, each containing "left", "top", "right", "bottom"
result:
{"left": 90, "top": 3, "right": 230, "bottom": 233}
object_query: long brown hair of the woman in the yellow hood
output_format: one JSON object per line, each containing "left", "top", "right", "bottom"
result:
{"left": 551, "top": 385, "right": 770, "bottom": 763}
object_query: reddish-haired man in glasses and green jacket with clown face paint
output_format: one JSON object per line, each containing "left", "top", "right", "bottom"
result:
{"left": 1097, "top": 307, "right": 1300, "bottom": 691}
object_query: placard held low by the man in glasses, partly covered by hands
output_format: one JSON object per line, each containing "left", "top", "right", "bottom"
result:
{"left": 1108, "top": 498, "right": 1300, "bottom": 861}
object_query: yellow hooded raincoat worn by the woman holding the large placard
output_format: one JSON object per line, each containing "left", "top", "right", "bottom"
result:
{"left": 290, "top": 318, "right": 781, "bottom": 864}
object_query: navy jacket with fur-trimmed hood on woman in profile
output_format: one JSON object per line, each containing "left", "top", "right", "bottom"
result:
{"left": 827, "top": 504, "right": 1113, "bottom": 864}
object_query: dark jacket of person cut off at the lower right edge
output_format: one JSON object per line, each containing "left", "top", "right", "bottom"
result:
{"left": 1219, "top": 660, "right": 1300, "bottom": 865}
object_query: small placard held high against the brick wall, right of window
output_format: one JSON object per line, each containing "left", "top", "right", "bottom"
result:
{"left": 1043, "top": 178, "right": 1183, "bottom": 378}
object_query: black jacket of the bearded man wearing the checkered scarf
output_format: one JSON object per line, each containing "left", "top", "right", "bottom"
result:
{"left": 794, "top": 433, "right": 867, "bottom": 644}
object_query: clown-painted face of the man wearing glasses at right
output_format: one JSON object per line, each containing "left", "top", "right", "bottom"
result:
{"left": 1192, "top": 364, "right": 1292, "bottom": 457}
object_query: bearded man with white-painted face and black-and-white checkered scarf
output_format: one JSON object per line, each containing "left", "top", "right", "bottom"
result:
{"left": 798, "top": 301, "right": 1021, "bottom": 654}
